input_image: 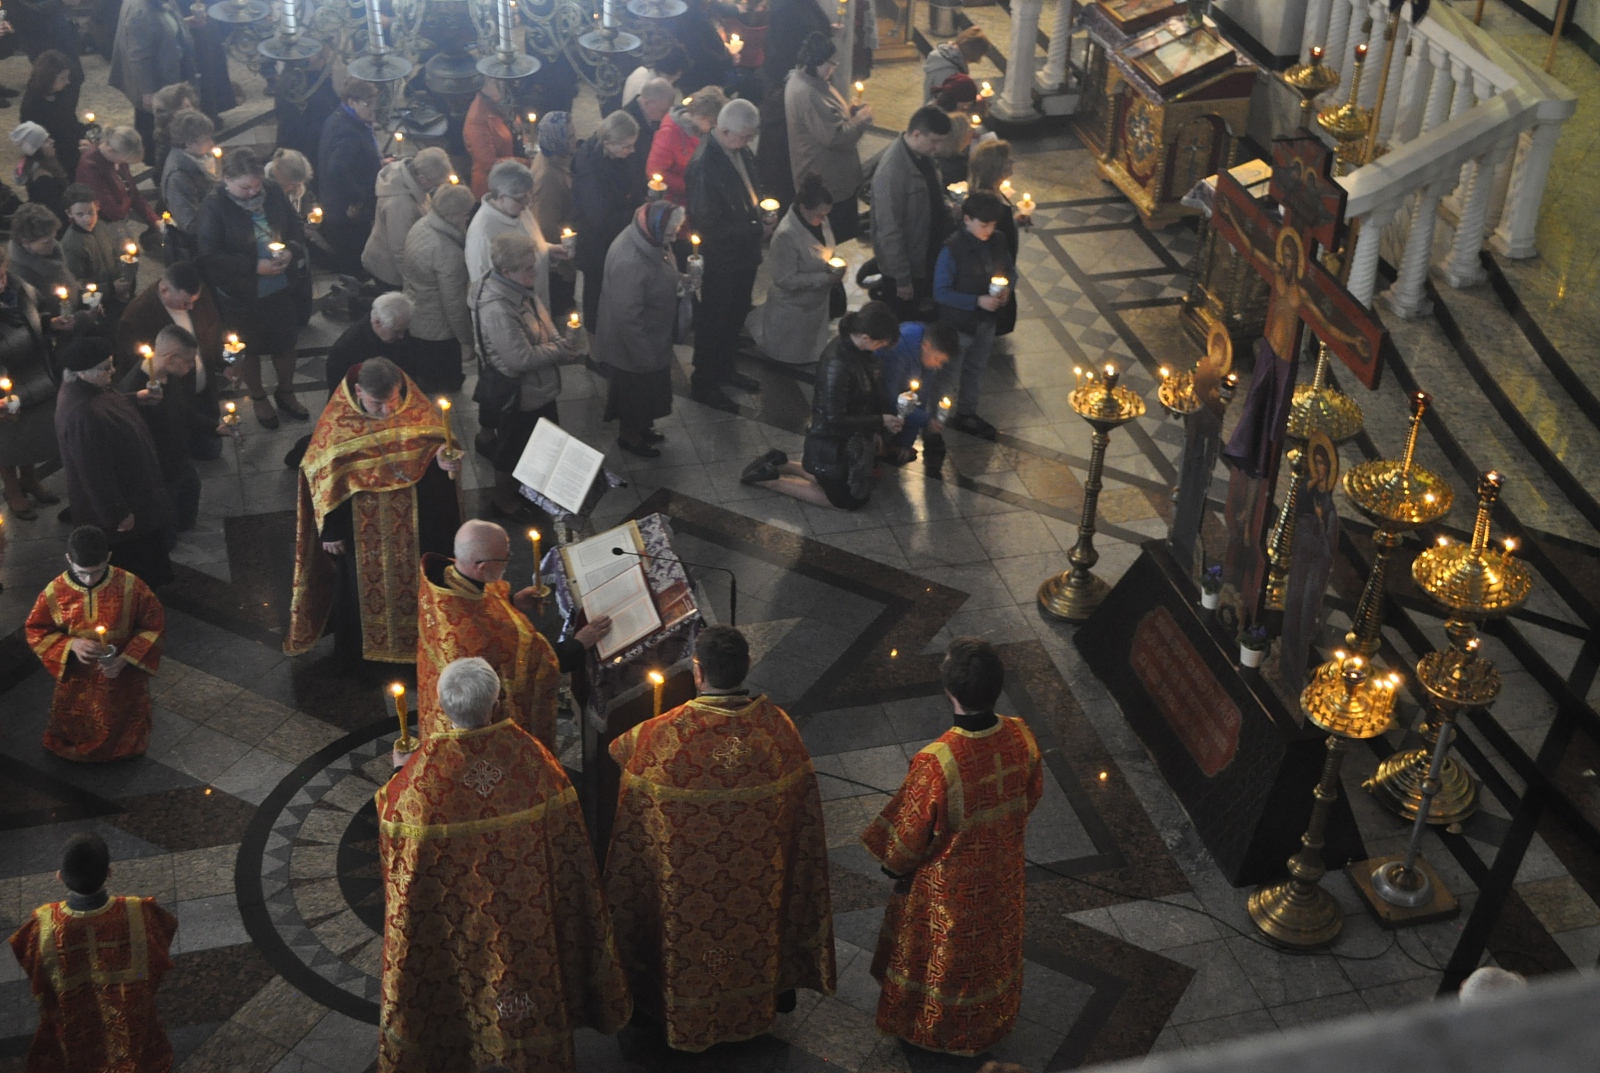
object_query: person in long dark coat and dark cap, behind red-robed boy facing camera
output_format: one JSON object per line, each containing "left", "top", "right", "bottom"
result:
{"left": 56, "top": 336, "right": 173, "bottom": 588}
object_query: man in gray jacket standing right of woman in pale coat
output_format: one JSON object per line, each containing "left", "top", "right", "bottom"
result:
{"left": 872, "top": 106, "right": 954, "bottom": 320}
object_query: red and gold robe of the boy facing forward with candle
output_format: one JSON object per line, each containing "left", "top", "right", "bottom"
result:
{"left": 26, "top": 566, "right": 166, "bottom": 760}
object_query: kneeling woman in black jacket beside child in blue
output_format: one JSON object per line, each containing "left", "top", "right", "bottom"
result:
{"left": 741, "top": 302, "right": 904, "bottom": 510}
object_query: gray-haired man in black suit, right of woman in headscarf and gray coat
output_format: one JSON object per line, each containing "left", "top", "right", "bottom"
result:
{"left": 683, "top": 99, "right": 776, "bottom": 409}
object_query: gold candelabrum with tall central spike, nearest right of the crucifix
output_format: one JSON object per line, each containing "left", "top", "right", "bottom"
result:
{"left": 1344, "top": 392, "right": 1456, "bottom": 659}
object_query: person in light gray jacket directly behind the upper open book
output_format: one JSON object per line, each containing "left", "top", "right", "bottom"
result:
{"left": 467, "top": 233, "right": 578, "bottom": 520}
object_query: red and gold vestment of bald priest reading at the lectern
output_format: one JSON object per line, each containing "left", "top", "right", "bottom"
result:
{"left": 416, "top": 555, "right": 562, "bottom": 752}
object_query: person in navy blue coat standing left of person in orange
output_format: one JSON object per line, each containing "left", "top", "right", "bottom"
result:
{"left": 317, "top": 78, "right": 384, "bottom": 277}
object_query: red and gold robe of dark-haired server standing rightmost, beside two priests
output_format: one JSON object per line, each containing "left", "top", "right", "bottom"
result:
{"left": 861, "top": 716, "right": 1045, "bottom": 1054}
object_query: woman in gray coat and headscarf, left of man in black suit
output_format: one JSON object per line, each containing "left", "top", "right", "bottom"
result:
{"left": 594, "top": 201, "right": 685, "bottom": 459}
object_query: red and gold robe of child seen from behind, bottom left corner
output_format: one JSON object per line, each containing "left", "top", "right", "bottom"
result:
{"left": 11, "top": 897, "right": 178, "bottom": 1073}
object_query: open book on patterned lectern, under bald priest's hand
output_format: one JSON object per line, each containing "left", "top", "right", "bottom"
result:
{"left": 562, "top": 521, "right": 694, "bottom": 659}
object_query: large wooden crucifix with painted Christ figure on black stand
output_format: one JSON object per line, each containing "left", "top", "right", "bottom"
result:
{"left": 1211, "top": 138, "right": 1387, "bottom": 620}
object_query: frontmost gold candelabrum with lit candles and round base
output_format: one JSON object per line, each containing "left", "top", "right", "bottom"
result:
{"left": 1245, "top": 652, "right": 1400, "bottom": 948}
